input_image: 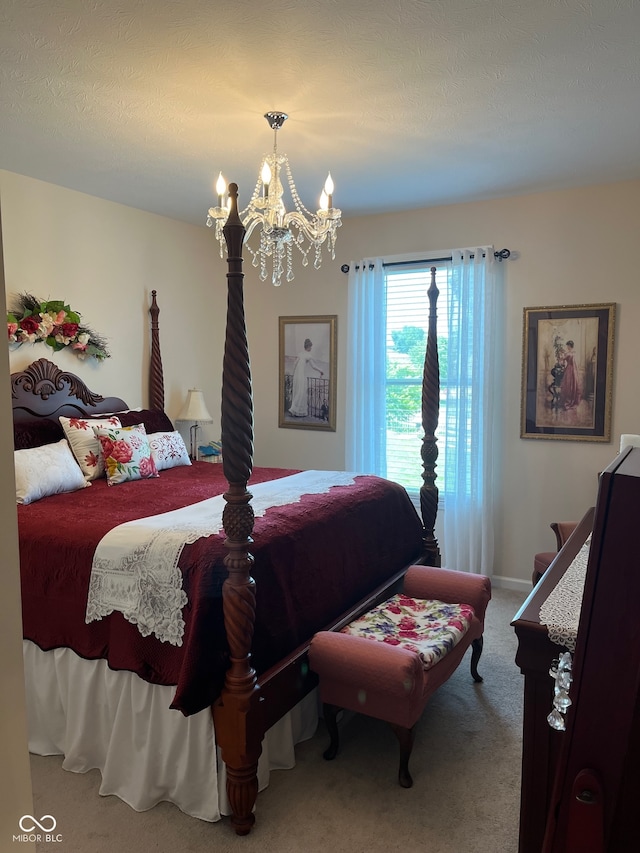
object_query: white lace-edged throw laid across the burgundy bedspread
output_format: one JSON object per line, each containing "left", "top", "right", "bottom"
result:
{"left": 85, "top": 471, "right": 356, "bottom": 646}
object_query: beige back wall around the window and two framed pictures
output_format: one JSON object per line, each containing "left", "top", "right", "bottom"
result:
{"left": 247, "top": 181, "right": 640, "bottom": 588}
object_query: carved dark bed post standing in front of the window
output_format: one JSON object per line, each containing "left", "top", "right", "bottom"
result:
{"left": 420, "top": 267, "right": 441, "bottom": 566}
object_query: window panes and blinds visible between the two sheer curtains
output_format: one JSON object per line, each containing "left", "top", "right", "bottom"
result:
{"left": 385, "top": 261, "right": 451, "bottom": 493}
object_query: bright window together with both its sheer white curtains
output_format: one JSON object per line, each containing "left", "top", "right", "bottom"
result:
{"left": 345, "top": 246, "right": 504, "bottom": 575}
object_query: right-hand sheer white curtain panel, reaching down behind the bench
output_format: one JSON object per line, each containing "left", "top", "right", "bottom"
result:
{"left": 439, "top": 247, "right": 502, "bottom": 575}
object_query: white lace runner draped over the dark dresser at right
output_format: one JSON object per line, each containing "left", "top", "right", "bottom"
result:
{"left": 540, "top": 534, "right": 591, "bottom": 652}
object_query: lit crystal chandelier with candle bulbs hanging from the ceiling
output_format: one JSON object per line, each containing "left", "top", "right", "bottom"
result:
{"left": 207, "top": 112, "right": 342, "bottom": 286}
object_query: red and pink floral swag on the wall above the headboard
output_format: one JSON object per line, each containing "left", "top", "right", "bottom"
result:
{"left": 7, "top": 293, "right": 111, "bottom": 361}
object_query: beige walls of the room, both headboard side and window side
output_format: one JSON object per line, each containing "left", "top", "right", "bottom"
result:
{"left": 0, "top": 172, "right": 640, "bottom": 587}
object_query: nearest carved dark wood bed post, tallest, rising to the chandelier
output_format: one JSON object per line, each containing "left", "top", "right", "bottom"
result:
{"left": 213, "top": 184, "right": 263, "bottom": 835}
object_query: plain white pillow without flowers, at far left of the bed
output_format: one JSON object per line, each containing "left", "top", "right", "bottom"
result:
{"left": 13, "top": 438, "right": 91, "bottom": 504}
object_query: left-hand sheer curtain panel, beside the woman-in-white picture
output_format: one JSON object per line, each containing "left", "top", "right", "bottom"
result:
{"left": 345, "top": 258, "right": 387, "bottom": 477}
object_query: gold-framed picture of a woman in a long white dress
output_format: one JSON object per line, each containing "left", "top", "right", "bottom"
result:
{"left": 278, "top": 314, "right": 338, "bottom": 432}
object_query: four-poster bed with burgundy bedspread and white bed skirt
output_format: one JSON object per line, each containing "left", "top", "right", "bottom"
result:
{"left": 16, "top": 185, "right": 440, "bottom": 834}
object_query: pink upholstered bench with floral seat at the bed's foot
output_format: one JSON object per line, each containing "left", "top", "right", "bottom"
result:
{"left": 309, "top": 566, "right": 491, "bottom": 788}
